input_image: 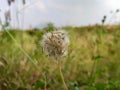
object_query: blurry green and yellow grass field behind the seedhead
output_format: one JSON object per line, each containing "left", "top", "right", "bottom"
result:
{"left": 0, "top": 25, "right": 120, "bottom": 90}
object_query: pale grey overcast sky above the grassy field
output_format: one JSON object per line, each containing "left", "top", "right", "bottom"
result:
{"left": 0, "top": 0, "right": 120, "bottom": 28}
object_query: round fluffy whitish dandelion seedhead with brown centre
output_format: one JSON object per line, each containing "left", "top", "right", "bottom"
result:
{"left": 41, "top": 30, "right": 69, "bottom": 60}
